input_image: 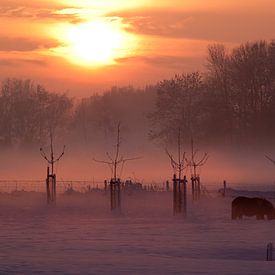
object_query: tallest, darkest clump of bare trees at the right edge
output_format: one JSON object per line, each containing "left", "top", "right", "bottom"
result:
{"left": 208, "top": 41, "right": 275, "bottom": 142}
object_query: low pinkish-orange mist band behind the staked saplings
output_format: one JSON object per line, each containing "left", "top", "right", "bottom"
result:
{"left": 0, "top": 142, "right": 275, "bottom": 190}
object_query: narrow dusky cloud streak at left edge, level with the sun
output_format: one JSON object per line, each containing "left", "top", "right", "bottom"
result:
{"left": 0, "top": 37, "right": 60, "bottom": 52}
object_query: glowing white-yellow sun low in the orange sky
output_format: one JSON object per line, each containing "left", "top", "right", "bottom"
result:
{"left": 53, "top": 21, "right": 136, "bottom": 67}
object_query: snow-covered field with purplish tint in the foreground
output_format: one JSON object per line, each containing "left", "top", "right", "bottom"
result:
{"left": 0, "top": 192, "right": 275, "bottom": 274}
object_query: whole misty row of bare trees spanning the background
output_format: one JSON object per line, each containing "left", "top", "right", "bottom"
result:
{"left": 0, "top": 41, "right": 275, "bottom": 150}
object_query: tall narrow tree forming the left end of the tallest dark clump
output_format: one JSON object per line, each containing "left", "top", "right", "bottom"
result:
{"left": 206, "top": 44, "right": 233, "bottom": 142}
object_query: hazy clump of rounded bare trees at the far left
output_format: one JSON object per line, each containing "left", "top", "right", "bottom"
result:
{"left": 0, "top": 79, "right": 73, "bottom": 146}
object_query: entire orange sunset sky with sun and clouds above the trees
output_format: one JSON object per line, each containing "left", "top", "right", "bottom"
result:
{"left": 0, "top": 0, "right": 275, "bottom": 97}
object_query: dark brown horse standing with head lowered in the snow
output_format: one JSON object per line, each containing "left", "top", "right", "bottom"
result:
{"left": 232, "top": 197, "right": 275, "bottom": 220}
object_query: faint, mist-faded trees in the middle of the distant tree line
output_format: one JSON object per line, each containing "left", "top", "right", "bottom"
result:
{"left": 73, "top": 87, "right": 155, "bottom": 142}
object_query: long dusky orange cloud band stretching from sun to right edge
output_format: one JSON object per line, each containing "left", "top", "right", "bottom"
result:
{"left": 110, "top": 9, "right": 275, "bottom": 43}
